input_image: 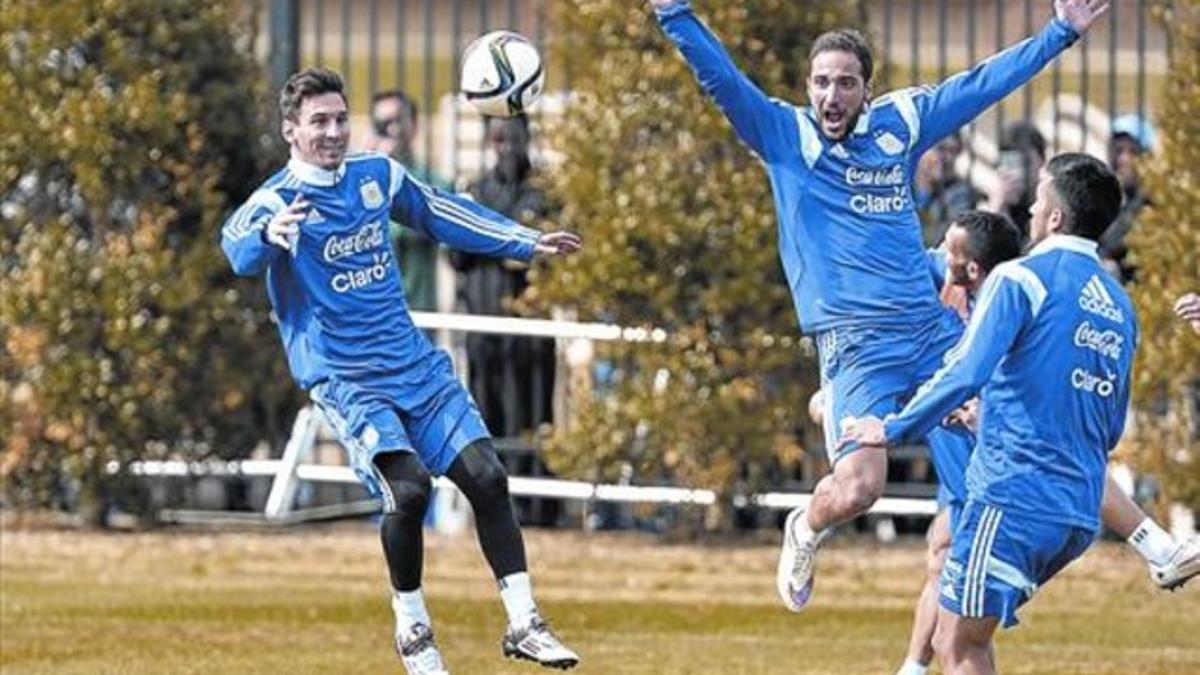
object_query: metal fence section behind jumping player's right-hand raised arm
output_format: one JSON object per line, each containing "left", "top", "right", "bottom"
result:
{"left": 865, "top": 0, "right": 1170, "bottom": 172}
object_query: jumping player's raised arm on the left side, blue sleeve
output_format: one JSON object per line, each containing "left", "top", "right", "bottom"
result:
{"left": 650, "top": 0, "right": 797, "bottom": 161}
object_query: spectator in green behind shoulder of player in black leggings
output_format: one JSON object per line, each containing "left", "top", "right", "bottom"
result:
{"left": 366, "top": 89, "right": 449, "bottom": 311}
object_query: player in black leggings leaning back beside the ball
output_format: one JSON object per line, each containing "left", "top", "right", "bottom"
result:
{"left": 221, "top": 68, "right": 581, "bottom": 674}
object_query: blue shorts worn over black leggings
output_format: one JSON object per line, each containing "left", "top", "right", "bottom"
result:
{"left": 308, "top": 352, "right": 491, "bottom": 497}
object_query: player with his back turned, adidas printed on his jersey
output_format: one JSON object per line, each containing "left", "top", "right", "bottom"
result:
{"left": 845, "top": 154, "right": 1138, "bottom": 673}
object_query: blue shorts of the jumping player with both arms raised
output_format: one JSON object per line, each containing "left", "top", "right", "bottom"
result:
{"left": 816, "top": 312, "right": 962, "bottom": 464}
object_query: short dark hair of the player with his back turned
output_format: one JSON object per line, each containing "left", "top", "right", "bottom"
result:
{"left": 1045, "top": 153, "right": 1122, "bottom": 241}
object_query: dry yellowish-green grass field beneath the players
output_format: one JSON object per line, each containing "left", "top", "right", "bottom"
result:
{"left": 0, "top": 522, "right": 1200, "bottom": 675}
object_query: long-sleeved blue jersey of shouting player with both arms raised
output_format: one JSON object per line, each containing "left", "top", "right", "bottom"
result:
{"left": 658, "top": 2, "right": 1079, "bottom": 333}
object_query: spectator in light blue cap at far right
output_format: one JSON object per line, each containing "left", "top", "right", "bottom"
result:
{"left": 1099, "top": 114, "right": 1156, "bottom": 283}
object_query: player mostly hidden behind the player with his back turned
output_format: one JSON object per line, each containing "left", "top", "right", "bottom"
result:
{"left": 896, "top": 211, "right": 1200, "bottom": 675}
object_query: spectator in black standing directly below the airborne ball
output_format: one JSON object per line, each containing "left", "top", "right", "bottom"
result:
{"left": 450, "top": 115, "right": 554, "bottom": 436}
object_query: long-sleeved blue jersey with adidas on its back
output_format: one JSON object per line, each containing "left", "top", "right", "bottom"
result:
{"left": 884, "top": 235, "right": 1138, "bottom": 530}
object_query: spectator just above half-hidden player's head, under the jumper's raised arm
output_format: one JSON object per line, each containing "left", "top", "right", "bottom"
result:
{"left": 913, "top": 132, "right": 979, "bottom": 249}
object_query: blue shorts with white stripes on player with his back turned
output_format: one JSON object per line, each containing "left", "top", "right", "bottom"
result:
{"left": 937, "top": 500, "right": 1096, "bottom": 628}
